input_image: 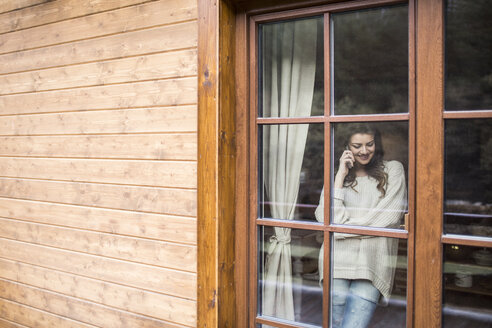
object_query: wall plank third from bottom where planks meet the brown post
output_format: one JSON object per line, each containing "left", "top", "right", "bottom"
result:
{"left": 0, "top": 217, "right": 196, "bottom": 272}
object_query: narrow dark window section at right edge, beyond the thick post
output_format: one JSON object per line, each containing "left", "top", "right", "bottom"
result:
{"left": 442, "top": 0, "right": 492, "bottom": 327}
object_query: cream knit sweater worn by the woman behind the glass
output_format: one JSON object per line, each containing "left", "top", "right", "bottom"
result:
{"left": 315, "top": 161, "right": 407, "bottom": 298}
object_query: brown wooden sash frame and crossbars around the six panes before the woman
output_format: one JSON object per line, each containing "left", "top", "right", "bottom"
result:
{"left": 248, "top": 0, "right": 415, "bottom": 327}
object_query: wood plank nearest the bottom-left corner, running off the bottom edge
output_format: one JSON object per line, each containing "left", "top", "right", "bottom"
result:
{"left": 0, "top": 298, "right": 95, "bottom": 328}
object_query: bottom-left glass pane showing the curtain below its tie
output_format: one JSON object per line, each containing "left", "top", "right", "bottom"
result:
{"left": 258, "top": 227, "right": 323, "bottom": 326}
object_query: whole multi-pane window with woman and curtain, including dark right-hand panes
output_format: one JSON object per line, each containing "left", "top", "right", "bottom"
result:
{"left": 238, "top": 0, "right": 492, "bottom": 327}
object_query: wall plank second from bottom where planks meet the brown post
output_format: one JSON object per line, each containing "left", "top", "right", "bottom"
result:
{"left": 0, "top": 238, "right": 196, "bottom": 300}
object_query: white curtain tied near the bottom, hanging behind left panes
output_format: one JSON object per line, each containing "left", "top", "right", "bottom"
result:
{"left": 262, "top": 19, "right": 322, "bottom": 320}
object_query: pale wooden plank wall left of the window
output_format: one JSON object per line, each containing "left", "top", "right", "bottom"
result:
{"left": 0, "top": 0, "right": 197, "bottom": 328}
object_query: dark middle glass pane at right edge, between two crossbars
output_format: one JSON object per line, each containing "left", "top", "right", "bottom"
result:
{"left": 444, "top": 119, "right": 492, "bottom": 237}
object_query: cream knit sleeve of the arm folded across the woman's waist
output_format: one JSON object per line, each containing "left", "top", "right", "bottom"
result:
{"left": 333, "top": 161, "right": 406, "bottom": 228}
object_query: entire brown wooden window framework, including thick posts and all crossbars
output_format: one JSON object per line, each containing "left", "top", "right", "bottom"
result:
{"left": 197, "top": 0, "right": 492, "bottom": 327}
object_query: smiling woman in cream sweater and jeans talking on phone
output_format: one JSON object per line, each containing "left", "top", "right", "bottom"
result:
{"left": 315, "top": 124, "right": 406, "bottom": 328}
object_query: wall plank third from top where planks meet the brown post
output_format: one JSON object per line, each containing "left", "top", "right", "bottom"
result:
{"left": 0, "top": 49, "right": 196, "bottom": 95}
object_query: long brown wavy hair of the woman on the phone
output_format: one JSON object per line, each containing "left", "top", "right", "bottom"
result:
{"left": 343, "top": 123, "right": 388, "bottom": 197}
